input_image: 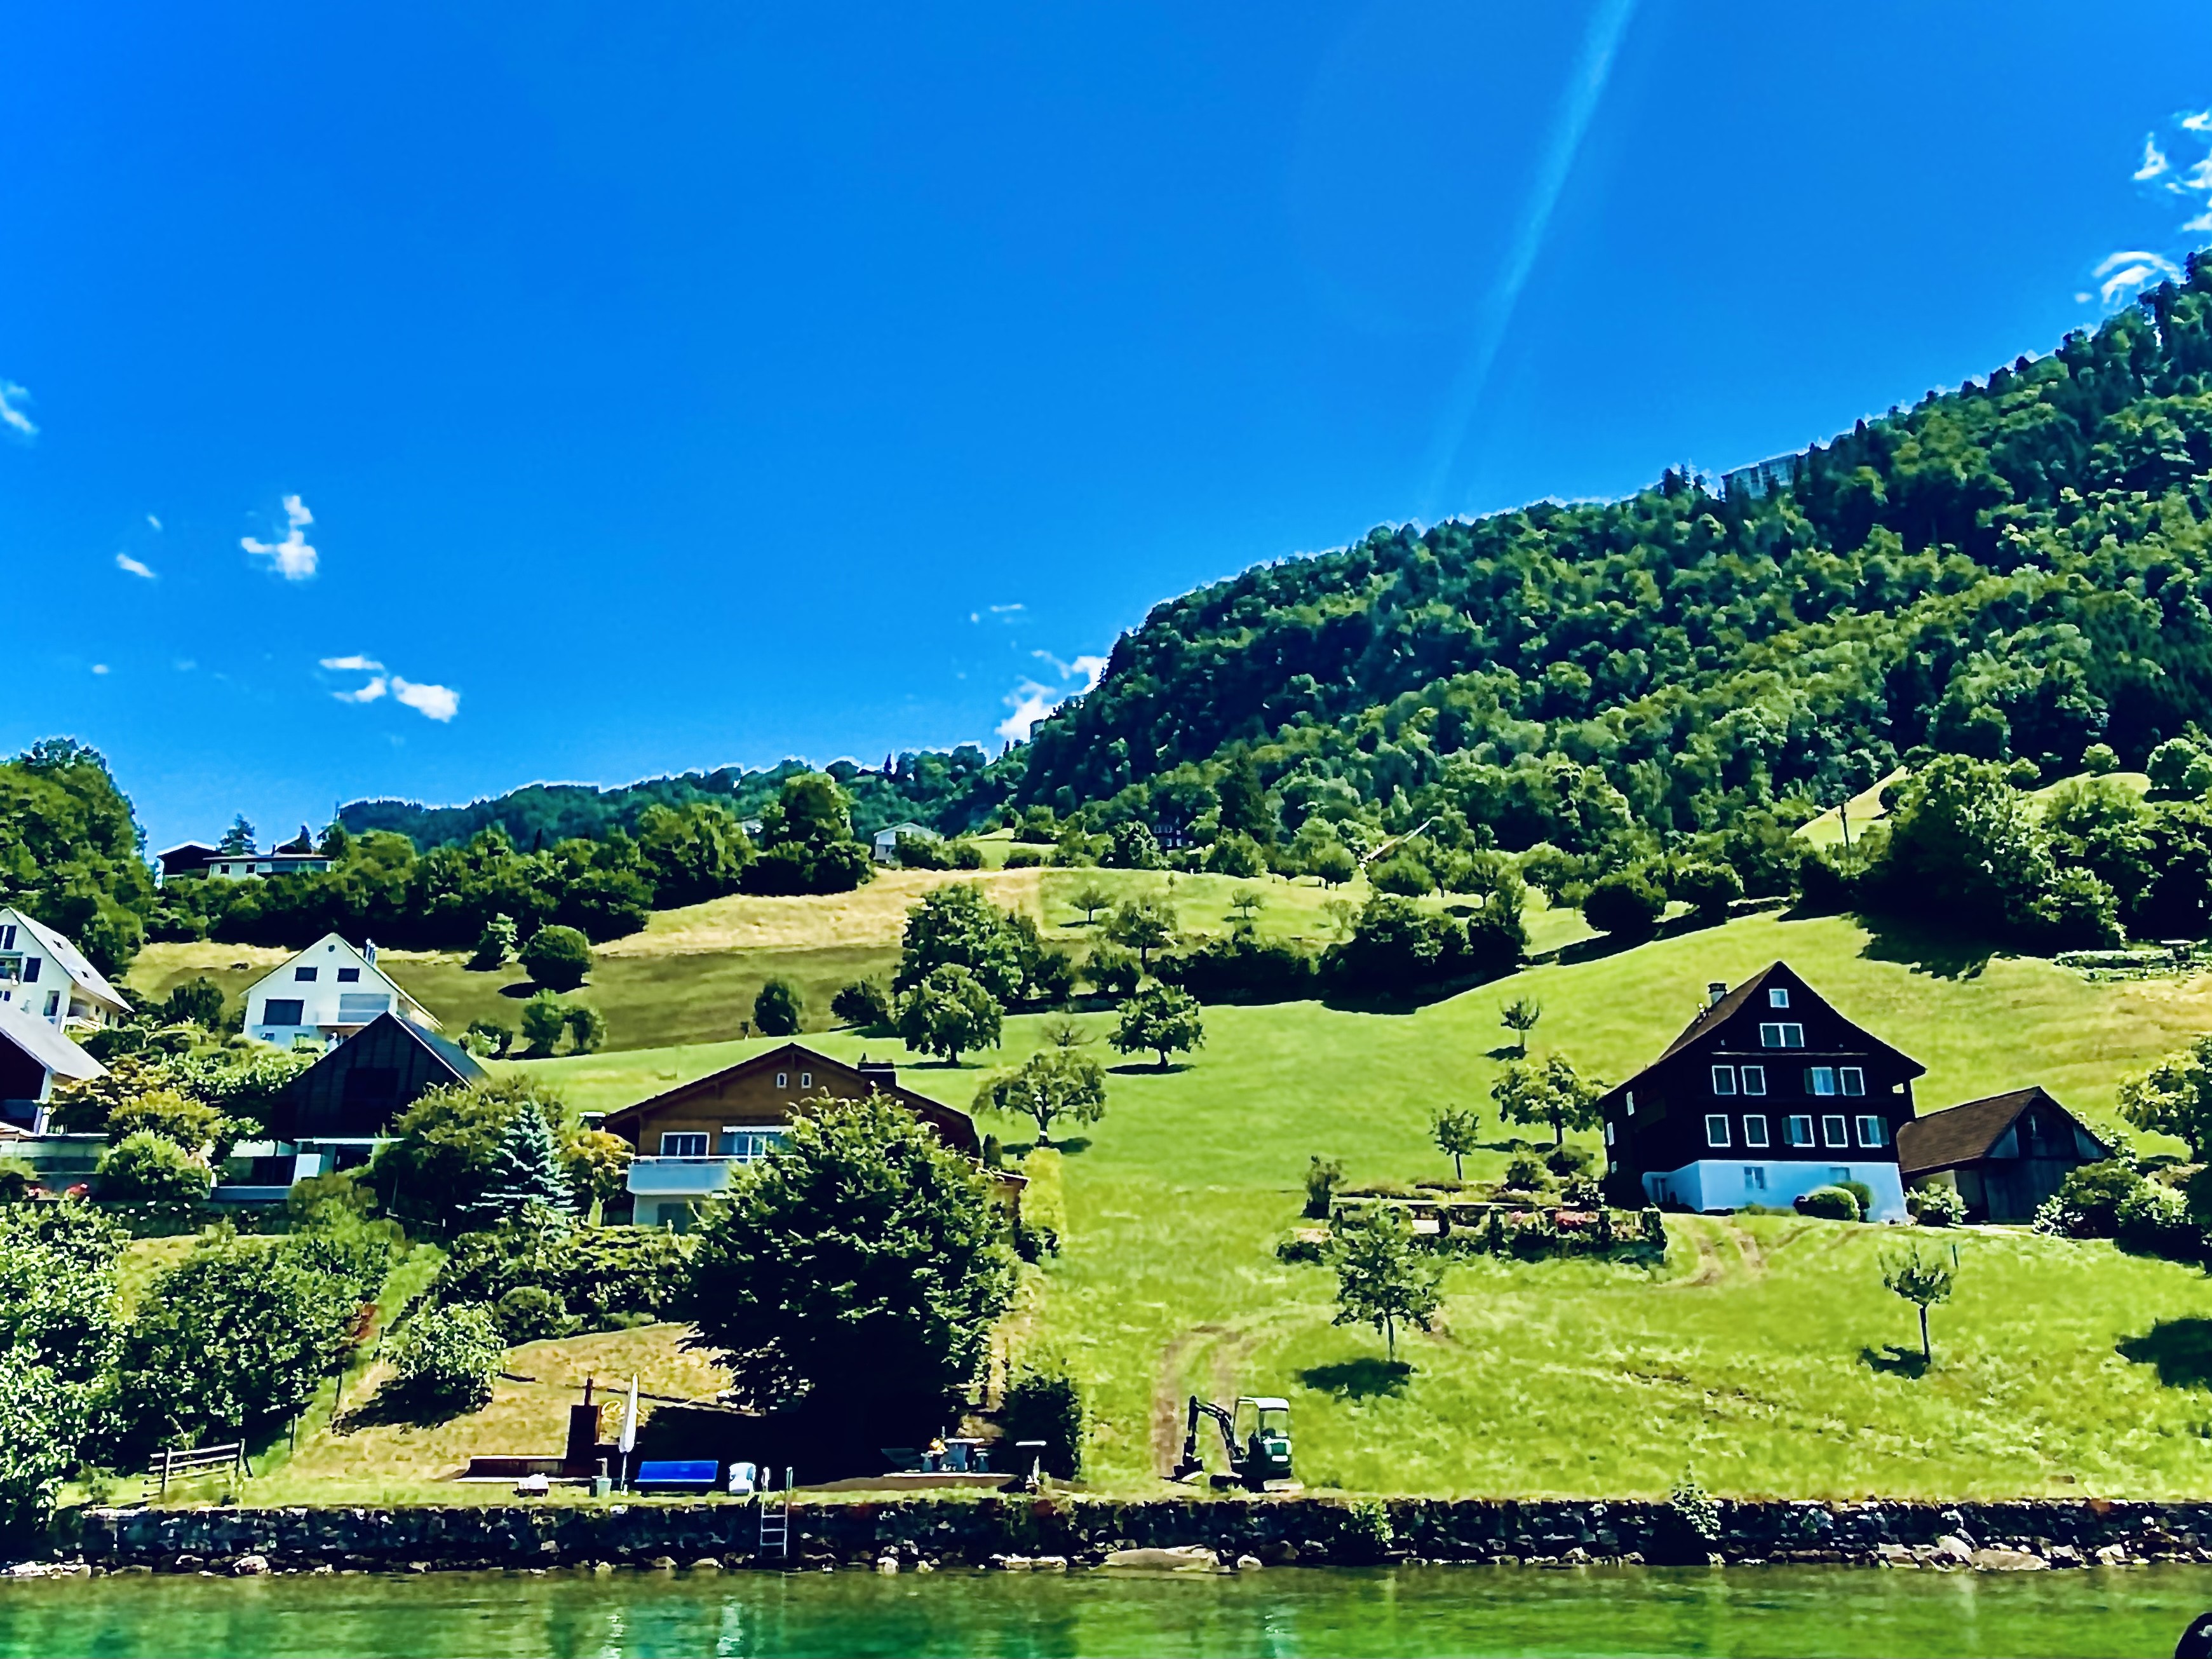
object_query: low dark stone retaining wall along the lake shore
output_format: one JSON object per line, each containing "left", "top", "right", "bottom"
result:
{"left": 55, "top": 1495, "right": 2212, "bottom": 1571}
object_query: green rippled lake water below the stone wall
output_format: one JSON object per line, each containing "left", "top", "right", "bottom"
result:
{"left": 0, "top": 1566, "right": 2212, "bottom": 1659}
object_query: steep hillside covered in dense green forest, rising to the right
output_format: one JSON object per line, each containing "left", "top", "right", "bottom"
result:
{"left": 1018, "top": 257, "right": 2212, "bottom": 847}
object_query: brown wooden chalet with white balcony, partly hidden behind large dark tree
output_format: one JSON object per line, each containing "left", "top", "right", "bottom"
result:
{"left": 600, "top": 1042, "right": 982, "bottom": 1230}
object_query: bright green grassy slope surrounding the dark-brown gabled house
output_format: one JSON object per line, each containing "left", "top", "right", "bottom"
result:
{"left": 522, "top": 916, "right": 2212, "bottom": 1495}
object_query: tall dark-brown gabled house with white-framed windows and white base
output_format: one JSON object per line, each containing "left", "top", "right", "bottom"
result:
{"left": 1599, "top": 962, "right": 1927, "bottom": 1221}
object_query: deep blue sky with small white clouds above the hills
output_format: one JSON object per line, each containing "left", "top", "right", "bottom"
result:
{"left": 0, "top": 0, "right": 2212, "bottom": 845}
